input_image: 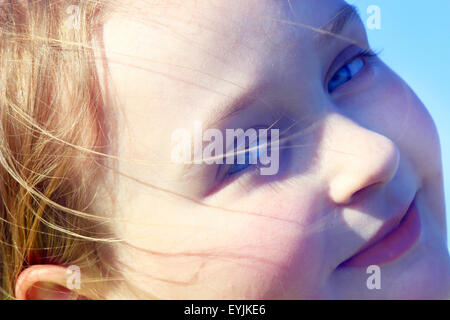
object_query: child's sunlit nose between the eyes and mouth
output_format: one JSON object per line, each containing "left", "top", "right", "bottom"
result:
{"left": 322, "top": 114, "right": 400, "bottom": 204}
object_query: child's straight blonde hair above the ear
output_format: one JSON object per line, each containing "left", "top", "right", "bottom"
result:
{"left": 0, "top": 0, "right": 121, "bottom": 299}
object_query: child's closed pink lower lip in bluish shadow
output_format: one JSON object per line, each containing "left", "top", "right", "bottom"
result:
{"left": 341, "top": 203, "right": 421, "bottom": 267}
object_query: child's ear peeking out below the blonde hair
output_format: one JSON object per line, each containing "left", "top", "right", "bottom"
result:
{"left": 15, "top": 265, "right": 86, "bottom": 300}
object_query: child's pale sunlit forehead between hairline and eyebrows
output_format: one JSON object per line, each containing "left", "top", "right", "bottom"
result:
{"left": 104, "top": 0, "right": 356, "bottom": 129}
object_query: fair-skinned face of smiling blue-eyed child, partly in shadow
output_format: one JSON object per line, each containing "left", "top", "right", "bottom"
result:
{"left": 98, "top": 0, "right": 449, "bottom": 299}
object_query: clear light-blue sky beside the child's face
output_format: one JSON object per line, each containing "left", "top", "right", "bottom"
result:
{"left": 348, "top": 0, "right": 450, "bottom": 252}
